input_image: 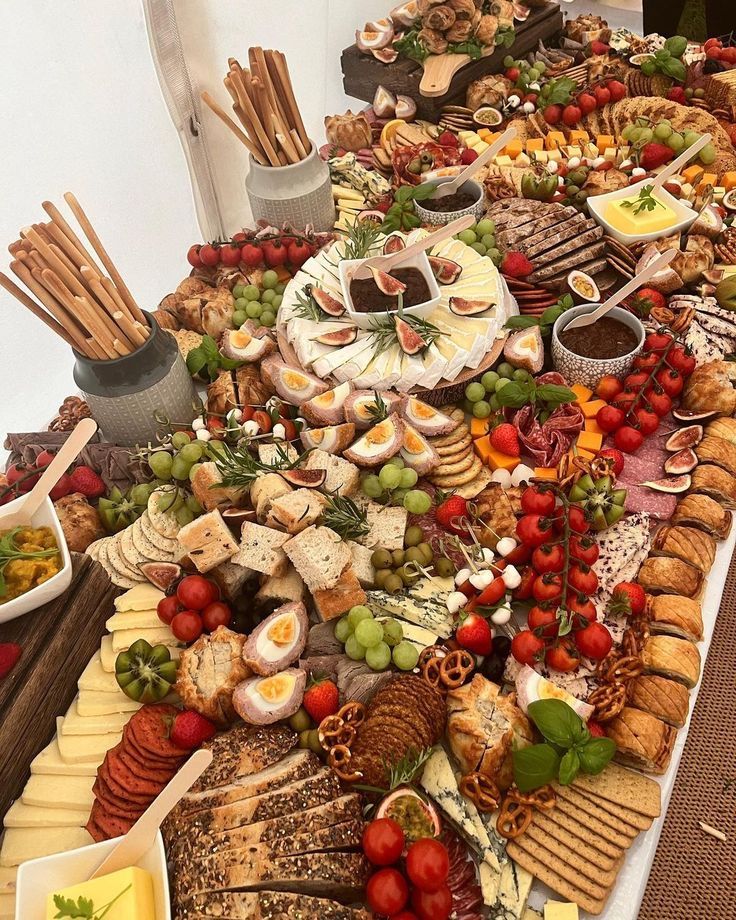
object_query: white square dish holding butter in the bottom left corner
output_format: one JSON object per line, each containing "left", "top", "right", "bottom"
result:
{"left": 15, "top": 833, "right": 171, "bottom": 920}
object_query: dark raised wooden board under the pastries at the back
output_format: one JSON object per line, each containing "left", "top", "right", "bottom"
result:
{"left": 341, "top": 3, "right": 562, "bottom": 122}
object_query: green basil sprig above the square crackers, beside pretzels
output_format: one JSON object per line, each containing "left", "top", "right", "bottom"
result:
{"left": 513, "top": 700, "right": 616, "bottom": 792}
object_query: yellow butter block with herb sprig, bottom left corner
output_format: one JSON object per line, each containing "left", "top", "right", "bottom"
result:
{"left": 46, "top": 866, "right": 156, "bottom": 920}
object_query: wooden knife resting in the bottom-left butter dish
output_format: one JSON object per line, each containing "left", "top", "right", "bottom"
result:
{"left": 90, "top": 750, "right": 212, "bottom": 879}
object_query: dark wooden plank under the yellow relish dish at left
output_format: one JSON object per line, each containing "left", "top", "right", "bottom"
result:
{"left": 0, "top": 553, "right": 121, "bottom": 815}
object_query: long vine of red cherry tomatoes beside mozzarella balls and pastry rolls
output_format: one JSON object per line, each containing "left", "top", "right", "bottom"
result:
{"left": 511, "top": 485, "right": 612, "bottom": 671}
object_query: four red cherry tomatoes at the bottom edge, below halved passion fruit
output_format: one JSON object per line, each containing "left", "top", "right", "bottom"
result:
{"left": 363, "top": 818, "right": 452, "bottom": 920}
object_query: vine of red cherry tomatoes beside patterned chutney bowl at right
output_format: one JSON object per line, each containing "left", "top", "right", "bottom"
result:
{"left": 595, "top": 332, "right": 695, "bottom": 454}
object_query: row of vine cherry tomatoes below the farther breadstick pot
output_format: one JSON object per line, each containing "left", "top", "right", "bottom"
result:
{"left": 187, "top": 233, "right": 317, "bottom": 269}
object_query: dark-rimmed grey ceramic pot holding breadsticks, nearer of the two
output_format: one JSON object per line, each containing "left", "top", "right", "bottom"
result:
{"left": 74, "top": 313, "right": 196, "bottom": 446}
